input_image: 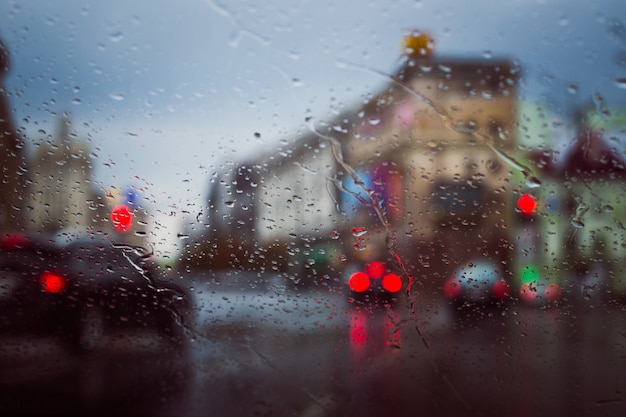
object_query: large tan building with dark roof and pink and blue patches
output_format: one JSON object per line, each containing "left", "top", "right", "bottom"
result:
{"left": 320, "top": 51, "right": 520, "bottom": 286}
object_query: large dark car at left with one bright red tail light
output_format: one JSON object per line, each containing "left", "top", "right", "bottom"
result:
{"left": 0, "top": 235, "right": 189, "bottom": 350}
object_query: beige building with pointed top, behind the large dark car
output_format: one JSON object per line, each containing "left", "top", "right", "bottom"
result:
{"left": 23, "top": 115, "right": 150, "bottom": 245}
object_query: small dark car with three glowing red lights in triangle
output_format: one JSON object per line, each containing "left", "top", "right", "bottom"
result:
{"left": 347, "top": 261, "right": 404, "bottom": 304}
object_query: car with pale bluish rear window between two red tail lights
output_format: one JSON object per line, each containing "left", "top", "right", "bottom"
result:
{"left": 443, "top": 259, "right": 511, "bottom": 307}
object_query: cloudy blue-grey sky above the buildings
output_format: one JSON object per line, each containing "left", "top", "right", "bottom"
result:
{"left": 0, "top": 0, "right": 626, "bottom": 254}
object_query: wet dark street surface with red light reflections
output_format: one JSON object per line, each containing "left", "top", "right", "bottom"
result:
{"left": 0, "top": 270, "right": 626, "bottom": 416}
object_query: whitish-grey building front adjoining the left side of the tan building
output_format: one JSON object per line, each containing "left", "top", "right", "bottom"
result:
{"left": 183, "top": 146, "right": 336, "bottom": 271}
